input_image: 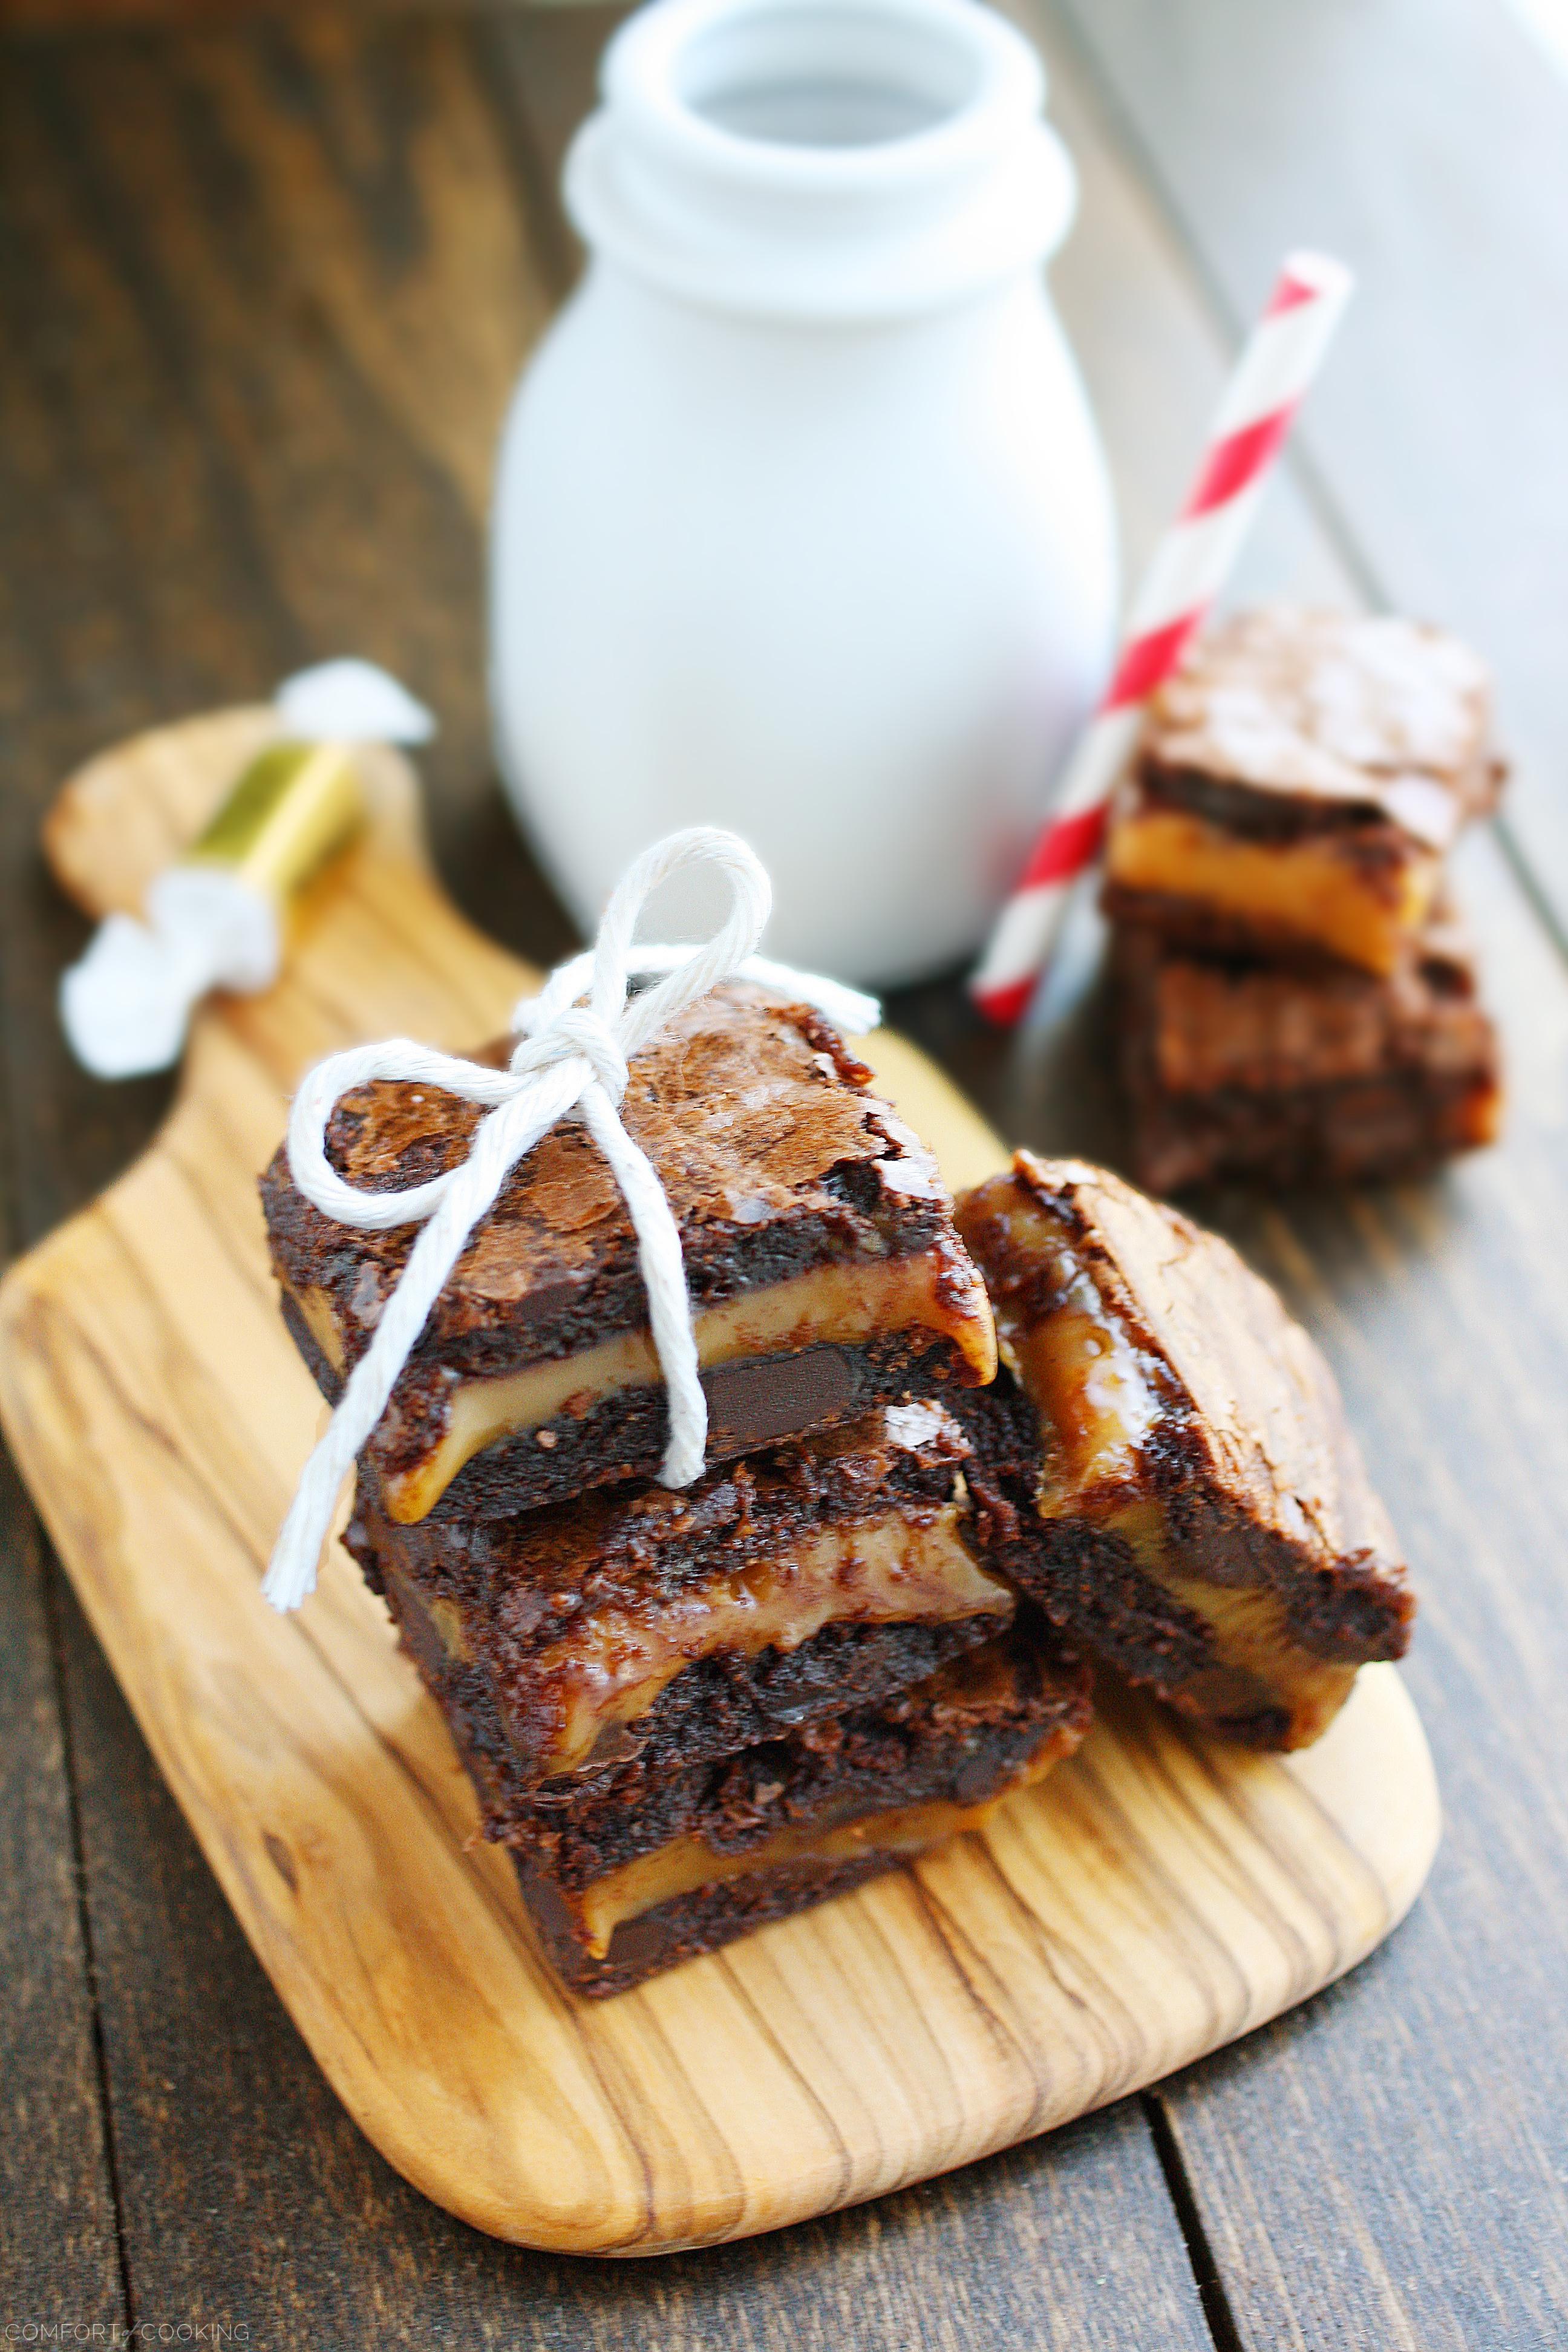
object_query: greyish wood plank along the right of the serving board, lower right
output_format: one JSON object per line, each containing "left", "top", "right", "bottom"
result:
{"left": 1114, "top": 840, "right": 1568, "bottom": 2352}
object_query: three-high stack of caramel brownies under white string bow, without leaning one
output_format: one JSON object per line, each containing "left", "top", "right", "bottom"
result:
{"left": 263, "top": 988, "right": 1088, "bottom": 1992}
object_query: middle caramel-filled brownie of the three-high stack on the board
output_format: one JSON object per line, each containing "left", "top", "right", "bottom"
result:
{"left": 348, "top": 1402, "right": 1013, "bottom": 1790}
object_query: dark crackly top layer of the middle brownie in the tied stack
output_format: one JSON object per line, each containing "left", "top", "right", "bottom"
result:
{"left": 367, "top": 1402, "right": 969, "bottom": 1642}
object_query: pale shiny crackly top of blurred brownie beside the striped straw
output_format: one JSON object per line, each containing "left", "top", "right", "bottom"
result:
{"left": 1143, "top": 604, "right": 1500, "bottom": 849}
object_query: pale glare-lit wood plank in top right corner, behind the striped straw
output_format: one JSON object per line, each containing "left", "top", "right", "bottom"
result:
{"left": 1056, "top": 0, "right": 1568, "bottom": 936}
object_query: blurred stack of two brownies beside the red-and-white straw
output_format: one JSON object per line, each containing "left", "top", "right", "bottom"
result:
{"left": 1103, "top": 607, "right": 1502, "bottom": 1192}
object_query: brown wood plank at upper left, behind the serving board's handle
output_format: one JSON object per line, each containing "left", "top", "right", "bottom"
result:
{"left": 0, "top": 7, "right": 569, "bottom": 1240}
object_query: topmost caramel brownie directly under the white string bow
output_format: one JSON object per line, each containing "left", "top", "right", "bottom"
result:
{"left": 261, "top": 985, "right": 995, "bottom": 1524}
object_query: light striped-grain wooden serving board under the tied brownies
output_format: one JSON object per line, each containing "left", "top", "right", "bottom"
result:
{"left": 0, "top": 710, "right": 1439, "bottom": 2253}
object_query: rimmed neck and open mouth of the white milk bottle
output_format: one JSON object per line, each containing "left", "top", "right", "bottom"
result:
{"left": 567, "top": 0, "right": 1077, "bottom": 322}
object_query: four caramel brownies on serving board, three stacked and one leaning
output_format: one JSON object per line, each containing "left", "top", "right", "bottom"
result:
{"left": 263, "top": 969, "right": 1413, "bottom": 1992}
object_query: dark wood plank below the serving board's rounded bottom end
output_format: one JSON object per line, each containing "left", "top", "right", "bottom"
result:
{"left": 40, "top": 1561, "right": 1208, "bottom": 2352}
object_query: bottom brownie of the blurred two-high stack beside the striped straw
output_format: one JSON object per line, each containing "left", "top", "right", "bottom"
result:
{"left": 1112, "top": 920, "right": 1502, "bottom": 1192}
